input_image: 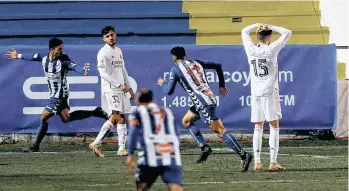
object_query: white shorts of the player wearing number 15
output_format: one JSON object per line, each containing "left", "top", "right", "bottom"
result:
{"left": 251, "top": 90, "right": 282, "bottom": 123}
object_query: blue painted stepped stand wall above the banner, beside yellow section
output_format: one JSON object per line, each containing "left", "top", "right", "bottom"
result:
{"left": 0, "top": 1, "right": 196, "bottom": 45}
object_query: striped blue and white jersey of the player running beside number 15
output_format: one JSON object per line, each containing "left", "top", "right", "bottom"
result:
{"left": 161, "top": 60, "right": 225, "bottom": 108}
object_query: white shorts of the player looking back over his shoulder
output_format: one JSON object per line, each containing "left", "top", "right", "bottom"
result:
{"left": 104, "top": 91, "right": 131, "bottom": 113}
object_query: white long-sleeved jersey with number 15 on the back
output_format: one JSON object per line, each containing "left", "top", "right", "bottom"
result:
{"left": 242, "top": 24, "right": 292, "bottom": 96}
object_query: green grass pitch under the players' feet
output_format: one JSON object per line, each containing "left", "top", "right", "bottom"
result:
{"left": 0, "top": 141, "right": 348, "bottom": 191}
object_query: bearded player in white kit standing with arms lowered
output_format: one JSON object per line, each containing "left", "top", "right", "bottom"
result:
{"left": 89, "top": 26, "right": 134, "bottom": 157}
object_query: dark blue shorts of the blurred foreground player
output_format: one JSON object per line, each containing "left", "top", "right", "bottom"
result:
{"left": 135, "top": 165, "right": 183, "bottom": 189}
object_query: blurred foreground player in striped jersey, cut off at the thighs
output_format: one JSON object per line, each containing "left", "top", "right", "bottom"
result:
{"left": 126, "top": 89, "right": 183, "bottom": 191}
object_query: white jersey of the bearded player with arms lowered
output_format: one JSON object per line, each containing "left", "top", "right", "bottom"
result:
{"left": 97, "top": 44, "right": 131, "bottom": 92}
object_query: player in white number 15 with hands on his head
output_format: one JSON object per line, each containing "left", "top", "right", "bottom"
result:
{"left": 241, "top": 24, "right": 292, "bottom": 170}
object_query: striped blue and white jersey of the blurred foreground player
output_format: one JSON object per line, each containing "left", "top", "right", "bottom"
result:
{"left": 128, "top": 103, "right": 182, "bottom": 167}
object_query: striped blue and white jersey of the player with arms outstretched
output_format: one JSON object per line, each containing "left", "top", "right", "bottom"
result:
{"left": 21, "top": 53, "right": 84, "bottom": 98}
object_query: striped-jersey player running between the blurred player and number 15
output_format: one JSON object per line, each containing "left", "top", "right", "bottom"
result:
{"left": 158, "top": 47, "right": 252, "bottom": 172}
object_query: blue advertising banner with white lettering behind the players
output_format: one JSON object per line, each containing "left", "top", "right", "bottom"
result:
{"left": 0, "top": 44, "right": 337, "bottom": 133}
